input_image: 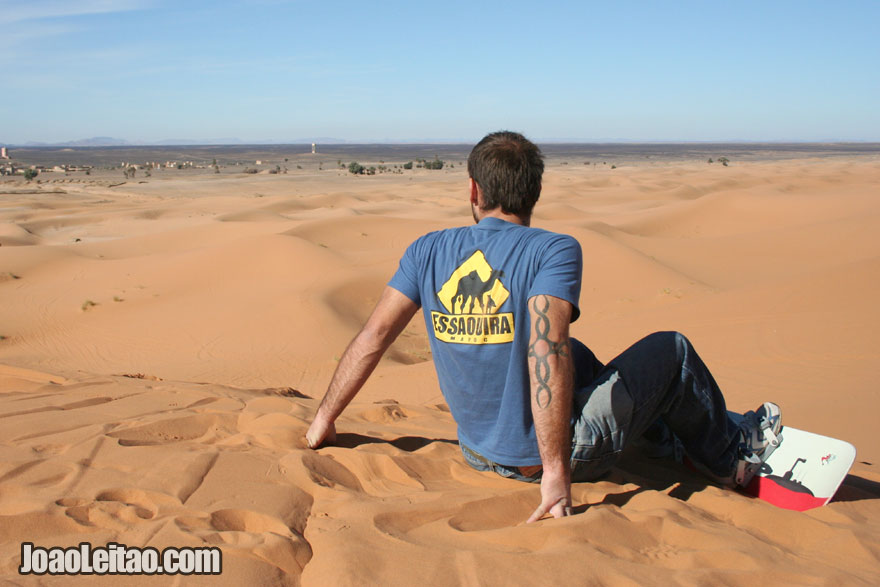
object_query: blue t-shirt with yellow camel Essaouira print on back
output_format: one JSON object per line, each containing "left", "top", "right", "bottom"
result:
{"left": 388, "top": 217, "right": 582, "bottom": 466}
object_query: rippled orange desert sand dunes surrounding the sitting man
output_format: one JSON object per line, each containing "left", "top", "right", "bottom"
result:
{"left": 0, "top": 156, "right": 880, "bottom": 585}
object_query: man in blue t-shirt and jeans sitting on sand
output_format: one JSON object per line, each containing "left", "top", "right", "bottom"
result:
{"left": 306, "top": 132, "right": 781, "bottom": 522}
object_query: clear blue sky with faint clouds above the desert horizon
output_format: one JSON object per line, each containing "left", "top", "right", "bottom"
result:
{"left": 0, "top": 0, "right": 880, "bottom": 144}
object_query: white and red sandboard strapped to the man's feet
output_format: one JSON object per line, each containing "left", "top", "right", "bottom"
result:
{"left": 731, "top": 414, "right": 856, "bottom": 511}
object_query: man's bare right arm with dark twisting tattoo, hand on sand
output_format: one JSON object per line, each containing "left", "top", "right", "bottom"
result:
{"left": 528, "top": 295, "right": 574, "bottom": 522}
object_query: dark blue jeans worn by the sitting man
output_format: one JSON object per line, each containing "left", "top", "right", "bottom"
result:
{"left": 461, "top": 332, "right": 739, "bottom": 482}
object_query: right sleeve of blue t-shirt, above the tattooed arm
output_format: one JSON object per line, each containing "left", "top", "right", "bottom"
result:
{"left": 528, "top": 235, "right": 583, "bottom": 322}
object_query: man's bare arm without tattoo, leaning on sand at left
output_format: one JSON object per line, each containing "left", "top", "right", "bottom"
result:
{"left": 306, "top": 286, "right": 419, "bottom": 448}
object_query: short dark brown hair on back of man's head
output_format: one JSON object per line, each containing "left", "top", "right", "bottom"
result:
{"left": 468, "top": 131, "right": 544, "bottom": 217}
